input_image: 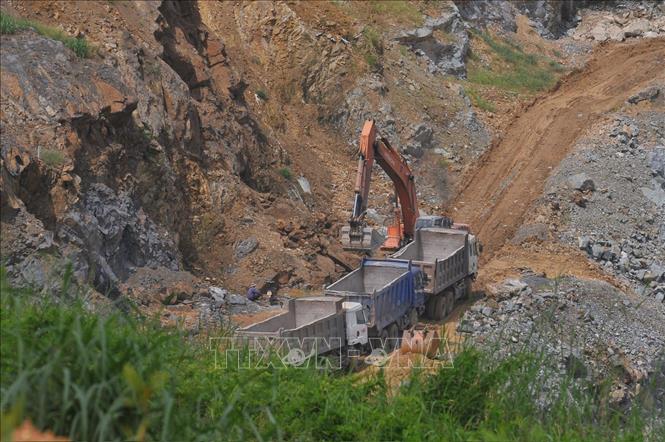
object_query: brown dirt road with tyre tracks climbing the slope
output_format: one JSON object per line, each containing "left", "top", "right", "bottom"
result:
{"left": 453, "top": 39, "right": 665, "bottom": 262}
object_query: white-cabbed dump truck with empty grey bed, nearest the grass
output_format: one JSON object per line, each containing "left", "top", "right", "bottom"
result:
{"left": 236, "top": 296, "right": 368, "bottom": 357}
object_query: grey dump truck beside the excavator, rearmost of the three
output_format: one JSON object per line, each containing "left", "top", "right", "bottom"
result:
{"left": 391, "top": 224, "right": 480, "bottom": 320}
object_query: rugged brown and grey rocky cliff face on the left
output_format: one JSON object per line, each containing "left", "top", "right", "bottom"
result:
{"left": 2, "top": 2, "right": 352, "bottom": 293}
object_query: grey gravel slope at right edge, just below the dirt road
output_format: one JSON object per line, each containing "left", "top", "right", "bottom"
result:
{"left": 546, "top": 109, "right": 665, "bottom": 296}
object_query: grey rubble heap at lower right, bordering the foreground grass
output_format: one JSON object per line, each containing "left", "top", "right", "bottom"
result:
{"left": 458, "top": 273, "right": 665, "bottom": 410}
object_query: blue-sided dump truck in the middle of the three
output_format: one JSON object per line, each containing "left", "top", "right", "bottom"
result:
{"left": 324, "top": 258, "right": 425, "bottom": 351}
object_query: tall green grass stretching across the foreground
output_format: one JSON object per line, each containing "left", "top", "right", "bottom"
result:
{"left": 0, "top": 271, "right": 657, "bottom": 441}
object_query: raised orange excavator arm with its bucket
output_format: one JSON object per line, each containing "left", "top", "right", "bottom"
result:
{"left": 342, "top": 120, "right": 418, "bottom": 250}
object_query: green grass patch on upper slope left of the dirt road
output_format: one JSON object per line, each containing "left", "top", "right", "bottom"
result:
{"left": 468, "top": 33, "right": 564, "bottom": 93}
